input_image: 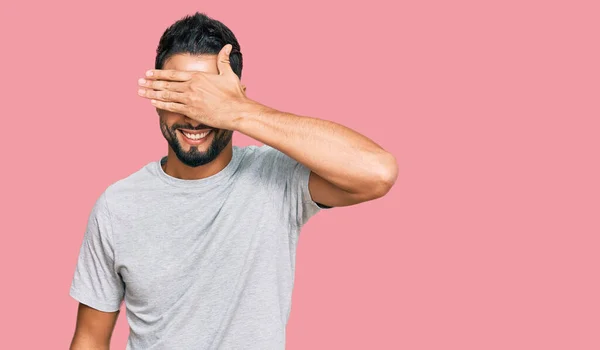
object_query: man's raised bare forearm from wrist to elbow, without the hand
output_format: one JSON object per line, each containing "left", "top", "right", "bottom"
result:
{"left": 235, "top": 101, "right": 398, "bottom": 193}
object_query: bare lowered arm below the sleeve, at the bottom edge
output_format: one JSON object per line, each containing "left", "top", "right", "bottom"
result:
{"left": 69, "top": 303, "right": 119, "bottom": 350}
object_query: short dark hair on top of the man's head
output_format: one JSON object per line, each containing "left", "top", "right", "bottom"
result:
{"left": 154, "top": 12, "right": 242, "bottom": 79}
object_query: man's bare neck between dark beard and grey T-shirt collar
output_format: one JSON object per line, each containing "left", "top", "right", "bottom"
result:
{"left": 162, "top": 142, "right": 233, "bottom": 180}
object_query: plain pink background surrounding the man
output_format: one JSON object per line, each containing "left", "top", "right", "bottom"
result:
{"left": 0, "top": 0, "right": 600, "bottom": 350}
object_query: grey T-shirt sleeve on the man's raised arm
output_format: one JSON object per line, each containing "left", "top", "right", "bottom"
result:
{"left": 261, "top": 145, "right": 326, "bottom": 227}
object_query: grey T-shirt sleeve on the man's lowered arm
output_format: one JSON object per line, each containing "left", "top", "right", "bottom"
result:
{"left": 69, "top": 192, "right": 125, "bottom": 312}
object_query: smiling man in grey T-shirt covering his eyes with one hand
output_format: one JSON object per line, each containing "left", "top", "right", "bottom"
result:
{"left": 70, "top": 13, "right": 397, "bottom": 350}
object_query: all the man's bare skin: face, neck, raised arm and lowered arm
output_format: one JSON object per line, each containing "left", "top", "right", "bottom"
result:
{"left": 71, "top": 45, "right": 398, "bottom": 344}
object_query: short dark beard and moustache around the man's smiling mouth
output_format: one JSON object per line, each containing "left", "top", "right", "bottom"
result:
{"left": 160, "top": 118, "right": 233, "bottom": 168}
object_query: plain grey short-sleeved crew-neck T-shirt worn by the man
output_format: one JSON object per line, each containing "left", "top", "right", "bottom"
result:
{"left": 70, "top": 146, "right": 320, "bottom": 350}
